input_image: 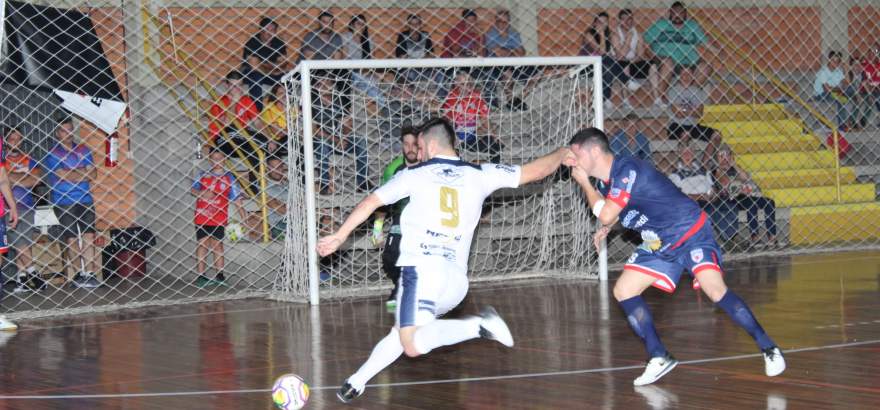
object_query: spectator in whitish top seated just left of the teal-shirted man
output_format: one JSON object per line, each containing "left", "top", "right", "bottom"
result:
{"left": 611, "top": 9, "right": 664, "bottom": 107}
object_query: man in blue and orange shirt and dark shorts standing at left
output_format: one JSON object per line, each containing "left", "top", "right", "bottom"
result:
{"left": 43, "top": 118, "right": 101, "bottom": 289}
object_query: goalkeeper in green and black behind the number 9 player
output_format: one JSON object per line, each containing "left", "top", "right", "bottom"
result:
{"left": 371, "top": 126, "right": 419, "bottom": 313}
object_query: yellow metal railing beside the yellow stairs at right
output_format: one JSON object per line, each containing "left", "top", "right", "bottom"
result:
{"left": 692, "top": 15, "right": 843, "bottom": 203}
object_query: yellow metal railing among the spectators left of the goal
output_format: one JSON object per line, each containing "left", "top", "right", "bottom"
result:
{"left": 141, "top": 2, "right": 271, "bottom": 242}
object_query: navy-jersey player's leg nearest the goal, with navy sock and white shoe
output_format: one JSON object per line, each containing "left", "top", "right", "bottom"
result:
{"left": 614, "top": 269, "right": 678, "bottom": 386}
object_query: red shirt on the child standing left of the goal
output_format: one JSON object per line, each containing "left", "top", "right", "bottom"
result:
{"left": 193, "top": 172, "right": 241, "bottom": 226}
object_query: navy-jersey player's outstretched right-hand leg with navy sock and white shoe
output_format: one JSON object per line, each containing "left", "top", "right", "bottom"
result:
{"left": 697, "top": 269, "right": 785, "bottom": 377}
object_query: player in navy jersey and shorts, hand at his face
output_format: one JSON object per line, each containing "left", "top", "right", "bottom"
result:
{"left": 565, "top": 128, "right": 785, "bottom": 386}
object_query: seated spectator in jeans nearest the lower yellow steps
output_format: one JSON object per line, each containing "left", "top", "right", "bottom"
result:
{"left": 714, "top": 144, "right": 776, "bottom": 247}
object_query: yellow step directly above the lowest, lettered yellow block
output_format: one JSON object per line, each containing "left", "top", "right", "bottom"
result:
{"left": 762, "top": 184, "right": 876, "bottom": 208}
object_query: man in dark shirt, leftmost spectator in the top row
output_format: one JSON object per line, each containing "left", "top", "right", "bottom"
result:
{"left": 241, "top": 17, "right": 290, "bottom": 109}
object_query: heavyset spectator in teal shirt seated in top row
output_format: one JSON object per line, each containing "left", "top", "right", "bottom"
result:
{"left": 645, "top": 1, "right": 709, "bottom": 98}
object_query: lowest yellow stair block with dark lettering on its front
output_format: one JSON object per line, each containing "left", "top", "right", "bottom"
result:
{"left": 789, "top": 202, "right": 880, "bottom": 245}
